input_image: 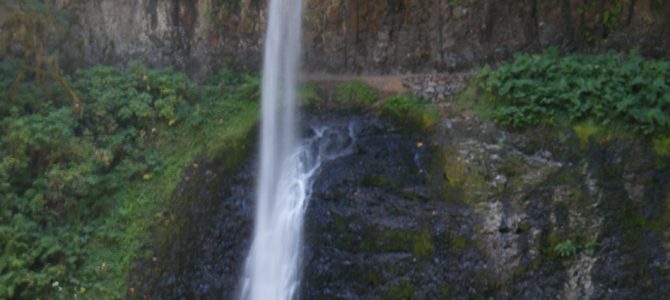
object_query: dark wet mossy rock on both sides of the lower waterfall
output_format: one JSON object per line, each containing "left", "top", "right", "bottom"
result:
{"left": 136, "top": 110, "right": 670, "bottom": 299}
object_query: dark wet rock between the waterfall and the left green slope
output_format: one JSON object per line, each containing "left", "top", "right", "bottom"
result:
{"left": 128, "top": 149, "right": 256, "bottom": 299}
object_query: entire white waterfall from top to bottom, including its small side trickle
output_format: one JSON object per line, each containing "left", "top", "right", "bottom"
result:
{"left": 240, "top": 0, "right": 353, "bottom": 300}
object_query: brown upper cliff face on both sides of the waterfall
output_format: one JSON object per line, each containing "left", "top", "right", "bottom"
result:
{"left": 53, "top": 0, "right": 670, "bottom": 74}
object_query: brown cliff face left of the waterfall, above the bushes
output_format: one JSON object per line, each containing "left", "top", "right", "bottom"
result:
{"left": 55, "top": 0, "right": 264, "bottom": 75}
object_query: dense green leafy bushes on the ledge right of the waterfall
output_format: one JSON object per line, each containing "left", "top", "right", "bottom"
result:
{"left": 479, "top": 51, "right": 670, "bottom": 135}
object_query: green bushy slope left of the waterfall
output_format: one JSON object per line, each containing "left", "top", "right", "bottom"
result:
{"left": 0, "top": 59, "right": 258, "bottom": 299}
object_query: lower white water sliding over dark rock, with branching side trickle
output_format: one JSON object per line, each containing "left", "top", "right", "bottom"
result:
{"left": 241, "top": 124, "right": 355, "bottom": 300}
